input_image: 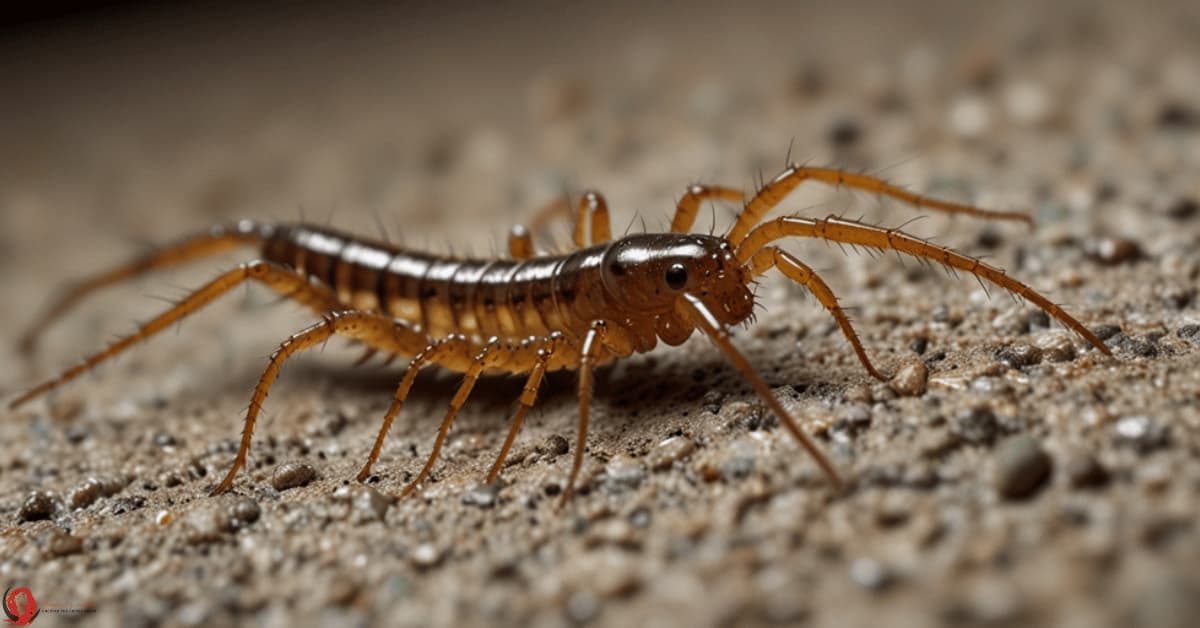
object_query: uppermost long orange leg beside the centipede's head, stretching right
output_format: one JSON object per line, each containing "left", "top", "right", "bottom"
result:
{"left": 726, "top": 163, "right": 1033, "bottom": 246}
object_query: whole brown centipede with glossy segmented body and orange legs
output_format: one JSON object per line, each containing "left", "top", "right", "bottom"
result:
{"left": 11, "top": 166, "right": 1109, "bottom": 501}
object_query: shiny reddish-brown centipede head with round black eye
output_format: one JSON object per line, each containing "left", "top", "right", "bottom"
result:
{"left": 602, "top": 233, "right": 754, "bottom": 345}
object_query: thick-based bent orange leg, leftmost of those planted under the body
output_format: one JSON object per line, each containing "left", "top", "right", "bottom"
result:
{"left": 212, "top": 310, "right": 428, "bottom": 495}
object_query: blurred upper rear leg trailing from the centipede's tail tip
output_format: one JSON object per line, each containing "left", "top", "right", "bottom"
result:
{"left": 18, "top": 221, "right": 266, "bottom": 354}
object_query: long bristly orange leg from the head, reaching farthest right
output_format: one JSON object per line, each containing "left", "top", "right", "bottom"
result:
{"left": 737, "top": 216, "right": 1112, "bottom": 355}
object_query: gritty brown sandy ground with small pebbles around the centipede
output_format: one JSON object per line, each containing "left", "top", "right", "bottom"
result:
{"left": 0, "top": 2, "right": 1200, "bottom": 627}
